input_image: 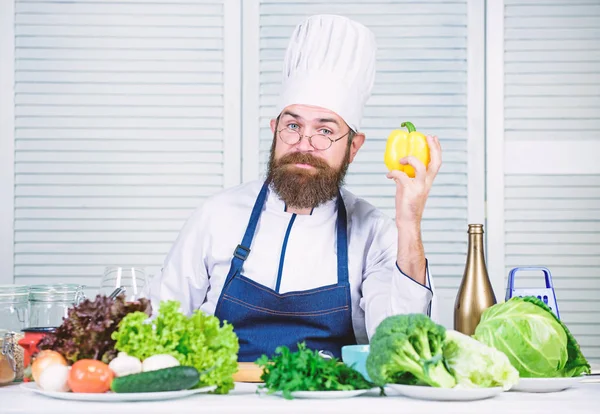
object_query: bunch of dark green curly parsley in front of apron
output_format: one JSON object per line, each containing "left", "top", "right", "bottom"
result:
{"left": 256, "top": 342, "right": 374, "bottom": 399}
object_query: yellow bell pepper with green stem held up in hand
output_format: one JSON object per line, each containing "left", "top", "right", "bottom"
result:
{"left": 383, "top": 122, "right": 430, "bottom": 178}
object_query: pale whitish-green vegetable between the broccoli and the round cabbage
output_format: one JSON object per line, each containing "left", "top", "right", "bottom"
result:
{"left": 444, "top": 330, "right": 519, "bottom": 390}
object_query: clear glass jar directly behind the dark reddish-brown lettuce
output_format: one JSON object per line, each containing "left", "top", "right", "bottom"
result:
{"left": 29, "top": 284, "right": 85, "bottom": 328}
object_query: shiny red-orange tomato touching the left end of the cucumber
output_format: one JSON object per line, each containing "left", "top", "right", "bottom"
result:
{"left": 67, "top": 359, "right": 115, "bottom": 393}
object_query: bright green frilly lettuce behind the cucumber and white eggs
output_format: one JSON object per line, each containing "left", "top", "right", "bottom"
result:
{"left": 112, "top": 301, "right": 239, "bottom": 394}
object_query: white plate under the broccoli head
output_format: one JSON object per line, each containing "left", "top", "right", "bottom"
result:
{"left": 386, "top": 384, "right": 503, "bottom": 401}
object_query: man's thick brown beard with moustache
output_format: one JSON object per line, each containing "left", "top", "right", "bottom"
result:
{"left": 267, "top": 138, "right": 350, "bottom": 208}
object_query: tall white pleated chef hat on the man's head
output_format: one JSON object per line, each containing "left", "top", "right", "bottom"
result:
{"left": 277, "top": 15, "right": 377, "bottom": 131}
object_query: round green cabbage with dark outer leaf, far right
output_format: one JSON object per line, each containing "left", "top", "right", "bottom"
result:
{"left": 473, "top": 296, "right": 590, "bottom": 378}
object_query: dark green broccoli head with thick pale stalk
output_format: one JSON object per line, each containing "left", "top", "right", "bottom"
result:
{"left": 367, "top": 314, "right": 456, "bottom": 388}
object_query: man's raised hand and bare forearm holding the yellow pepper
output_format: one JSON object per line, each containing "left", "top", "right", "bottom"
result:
{"left": 387, "top": 135, "right": 442, "bottom": 284}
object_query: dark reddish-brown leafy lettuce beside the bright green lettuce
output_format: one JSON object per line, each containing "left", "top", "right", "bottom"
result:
{"left": 38, "top": 295, "right": 152, "bottom": 364}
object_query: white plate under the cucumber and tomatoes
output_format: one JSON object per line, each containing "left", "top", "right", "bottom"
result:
{"left": 21, "top": 382, "right": 217, "bottom": 402}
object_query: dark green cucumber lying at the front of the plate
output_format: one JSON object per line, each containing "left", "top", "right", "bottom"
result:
{"left": 110, "top": 365, "right": 200, "bottom": 393}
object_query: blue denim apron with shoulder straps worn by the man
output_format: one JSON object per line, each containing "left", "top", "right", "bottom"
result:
{"left": 215, "top": 183, "right": 356, "bottom": 362}
